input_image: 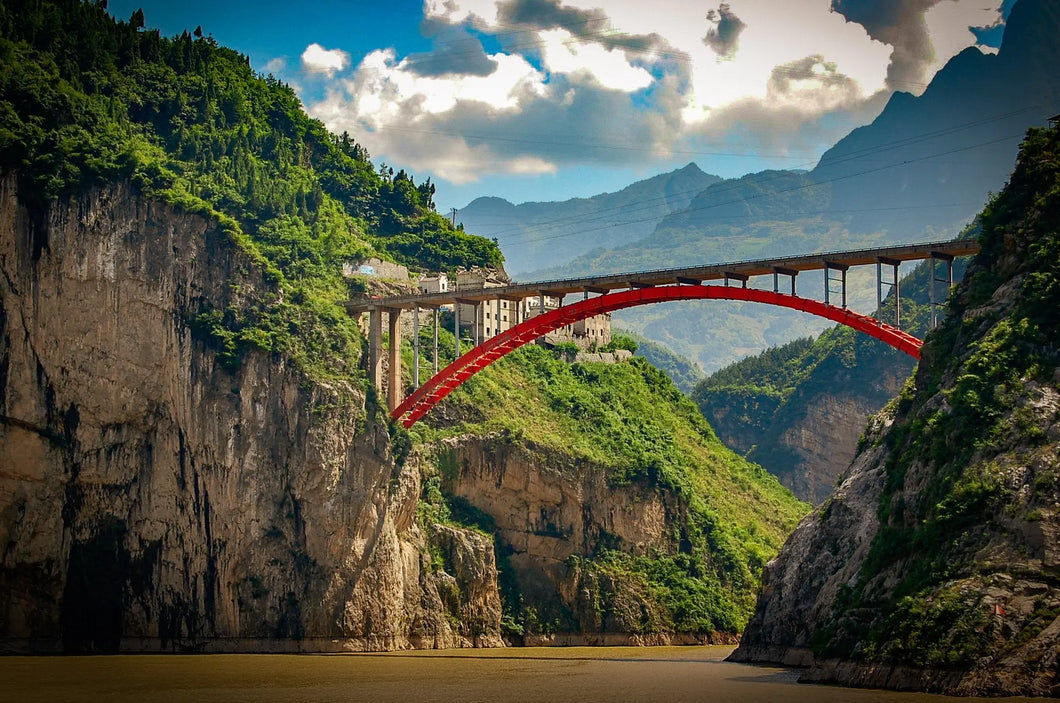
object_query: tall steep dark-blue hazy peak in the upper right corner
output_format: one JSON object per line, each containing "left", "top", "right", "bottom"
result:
{"left": 813, "top": 0, "right": 1060, "bottom": 237}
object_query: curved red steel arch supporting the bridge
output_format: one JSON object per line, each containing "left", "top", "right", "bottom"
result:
{"left": 390, "top": 285, "right": 923, "bottom": 427}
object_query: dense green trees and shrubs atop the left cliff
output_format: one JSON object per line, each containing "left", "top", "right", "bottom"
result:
{"left": 0, "top": 0, "right": 501, "bottom": 375}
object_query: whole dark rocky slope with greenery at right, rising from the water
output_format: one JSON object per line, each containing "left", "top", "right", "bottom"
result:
{"left": 732, "top": 127, "right": 1060, "bottom": 696}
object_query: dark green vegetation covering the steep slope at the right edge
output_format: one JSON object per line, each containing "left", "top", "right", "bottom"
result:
{"left": 815, "top": 129, "right": 1060, "bottom": 670}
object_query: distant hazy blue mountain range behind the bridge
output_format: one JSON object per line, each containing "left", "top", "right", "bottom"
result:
{"left": 461, "top": 0, "right": 1060, "bottom": 371}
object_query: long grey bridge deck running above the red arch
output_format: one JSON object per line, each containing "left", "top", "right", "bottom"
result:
{"left": 347, "top": 240, "right": 979, "bottom": 314}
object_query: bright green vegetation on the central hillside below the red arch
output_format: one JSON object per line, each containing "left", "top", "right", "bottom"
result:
{"left": 412, "top": 346, "right": 807, "bottom": 634}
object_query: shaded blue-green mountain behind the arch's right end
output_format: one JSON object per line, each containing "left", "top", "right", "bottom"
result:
{"left": 692, "top": 254, "right": 975, "bottom": 505}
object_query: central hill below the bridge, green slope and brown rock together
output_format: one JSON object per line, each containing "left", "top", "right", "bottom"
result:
{"left": 411, "top": 337, "right": 808, "bottom": 645}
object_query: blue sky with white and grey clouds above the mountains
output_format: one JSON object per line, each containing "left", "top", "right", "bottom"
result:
{"left": 108, "top": 0, "right": 1014, "bottom": 212}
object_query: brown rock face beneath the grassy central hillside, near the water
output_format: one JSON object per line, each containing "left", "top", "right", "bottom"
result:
{"left": 426, "top": 436, "right": 735, "bottom": 645}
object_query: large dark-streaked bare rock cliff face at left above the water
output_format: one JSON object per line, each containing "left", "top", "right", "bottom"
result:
{"left": 0, "top": 178, "right": 500, "bottom": 652}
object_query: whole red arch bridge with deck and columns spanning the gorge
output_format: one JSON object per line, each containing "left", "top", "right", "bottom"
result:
{"left": 347, "top": 240, "right": 978, "bottom": 427}
